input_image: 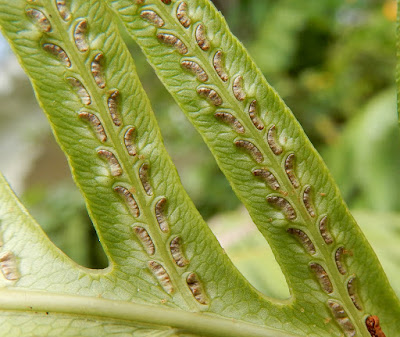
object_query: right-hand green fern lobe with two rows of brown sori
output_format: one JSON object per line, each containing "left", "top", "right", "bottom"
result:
{"left": 109, "top": 0, "right": 400, "bottom": 336}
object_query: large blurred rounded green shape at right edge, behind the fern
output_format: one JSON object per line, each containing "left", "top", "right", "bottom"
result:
{"left": 323, "top": 88, "right": 400, "bottom": 212}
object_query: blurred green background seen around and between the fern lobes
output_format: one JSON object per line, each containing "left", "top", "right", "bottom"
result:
{"left": 0, "top": 0, "right": 400, "bottom": 297}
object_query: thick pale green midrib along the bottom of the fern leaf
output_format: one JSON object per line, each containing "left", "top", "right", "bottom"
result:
{"left": 0, "top": 289, "right": 300, "bottom": 337}
